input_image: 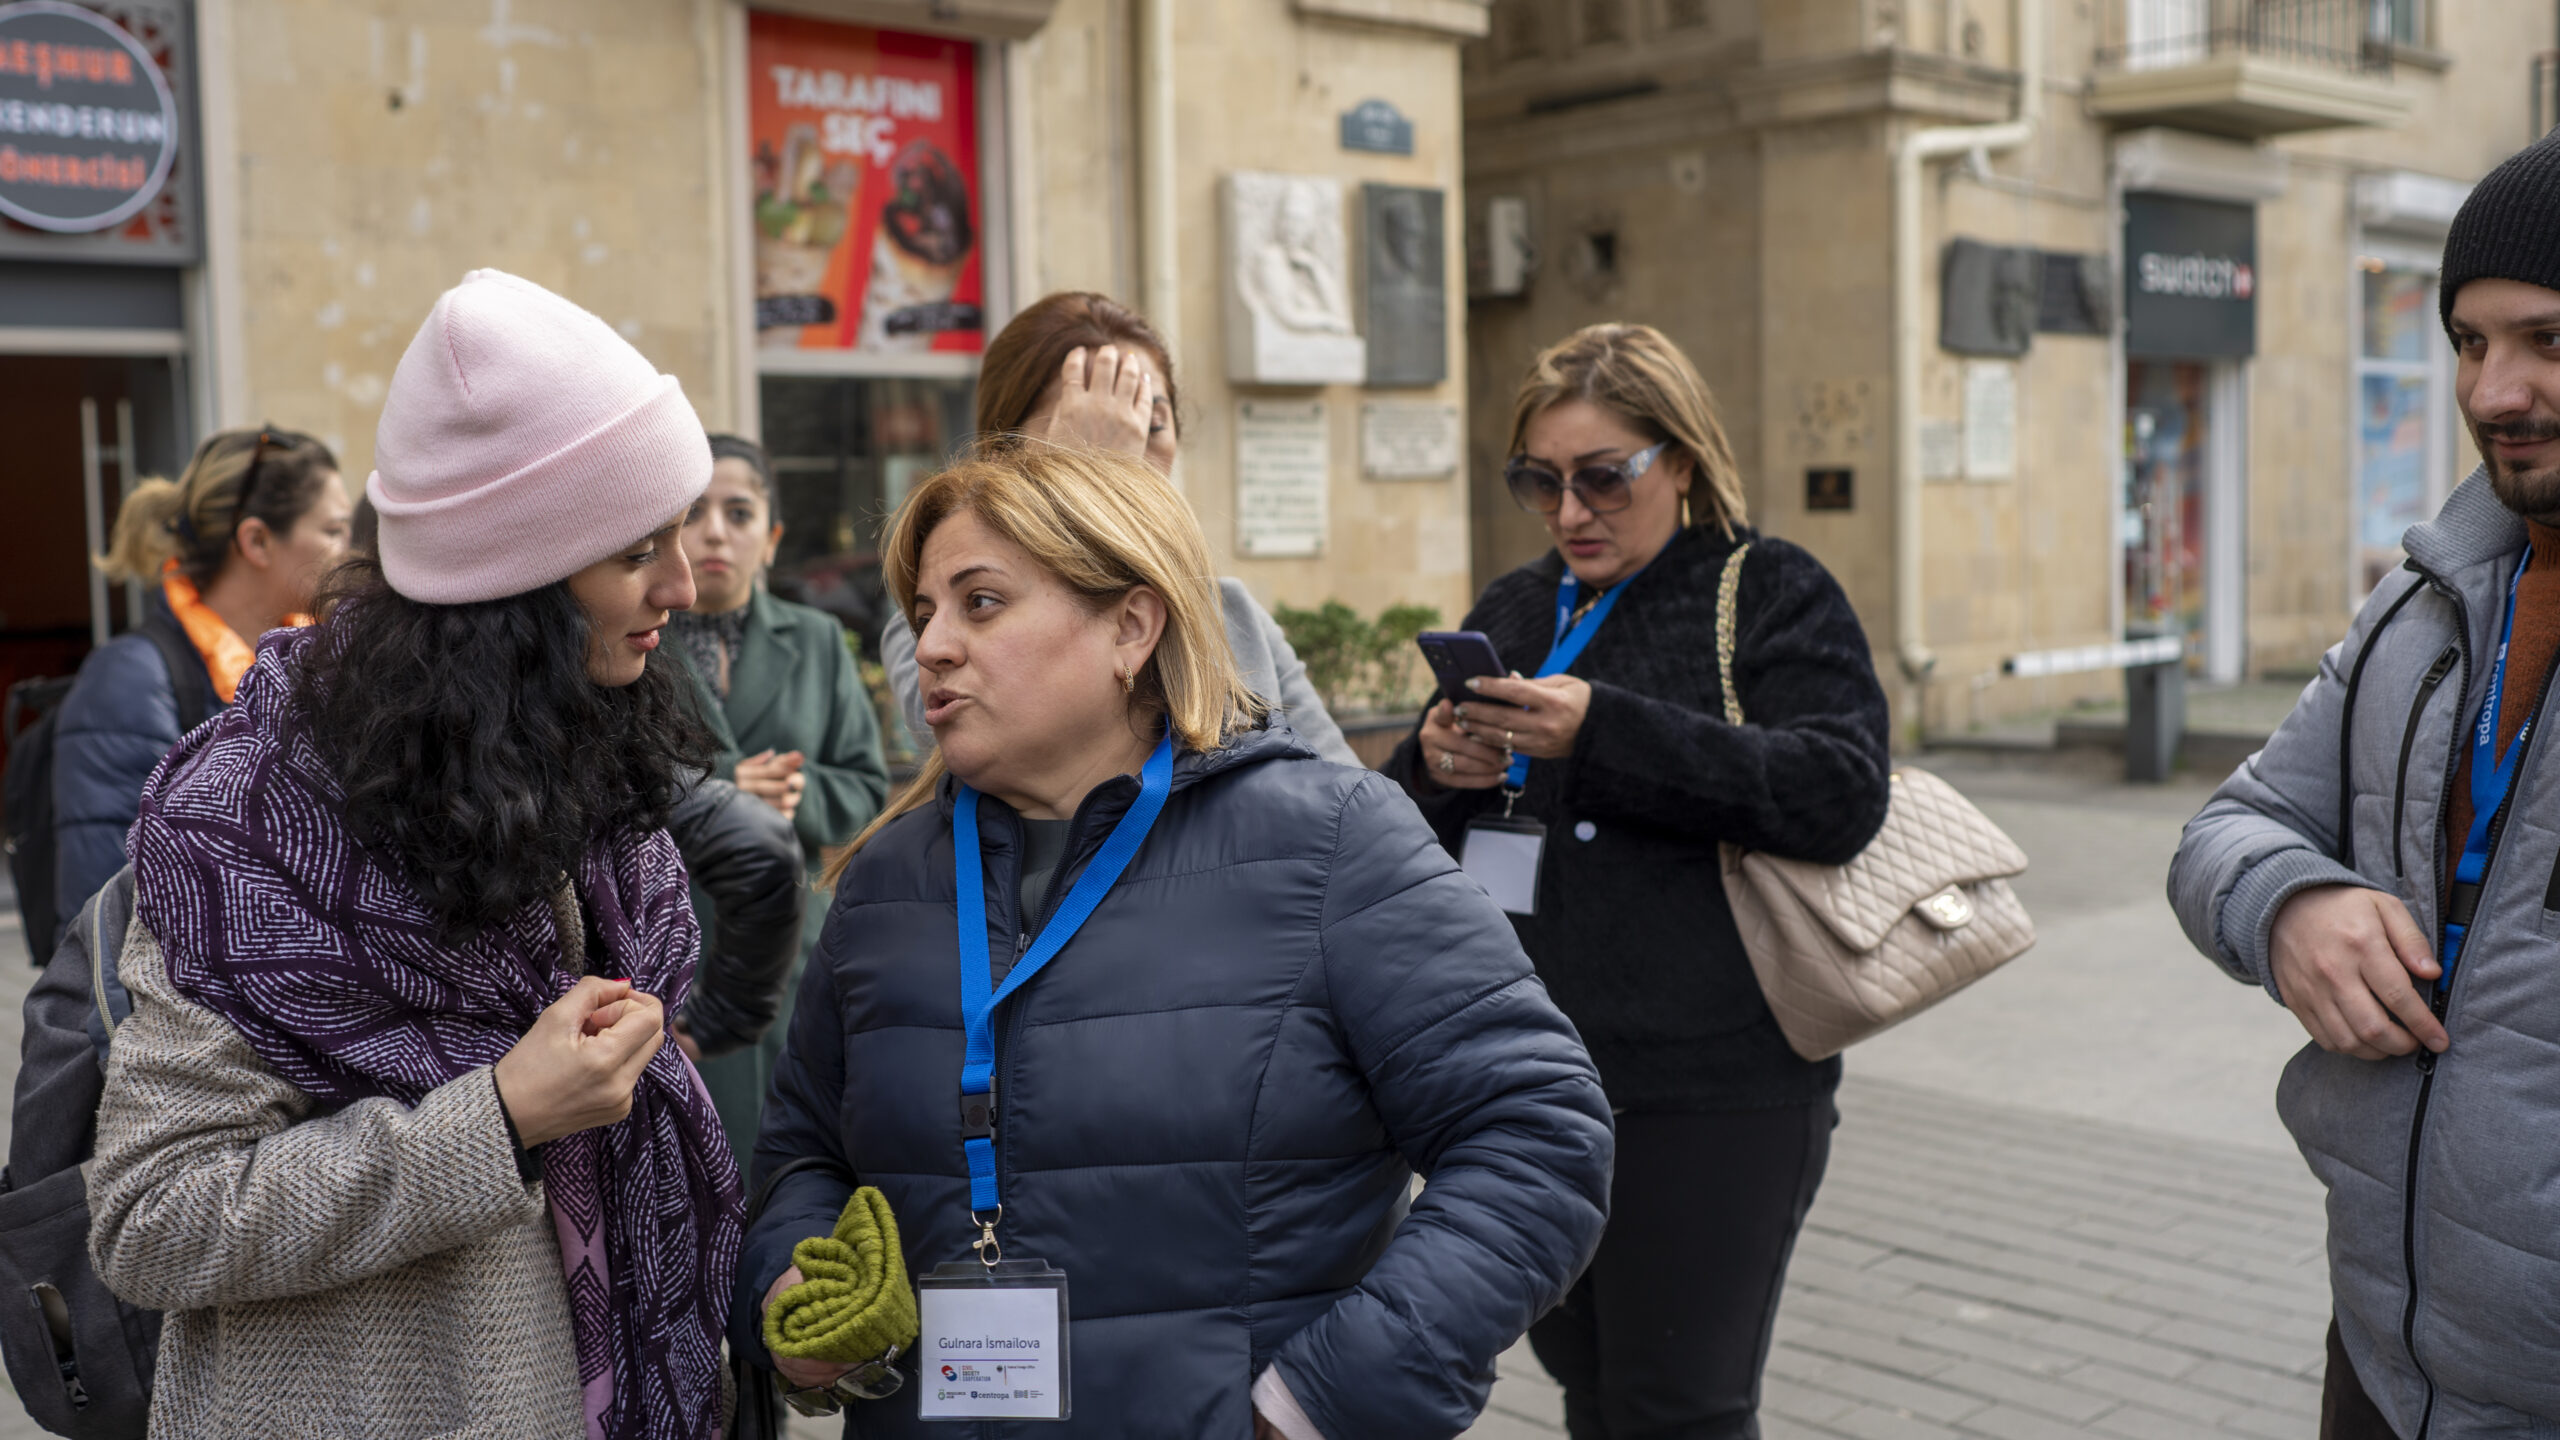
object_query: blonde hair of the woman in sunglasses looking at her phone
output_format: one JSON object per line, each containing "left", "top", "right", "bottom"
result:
{"left": 1508, "top": 325, "right": 1748, "bottom": 536}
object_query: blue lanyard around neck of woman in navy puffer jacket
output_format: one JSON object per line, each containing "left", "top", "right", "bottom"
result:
{"left": 952, "top": 730, "right": 1172, "bottom": 1209}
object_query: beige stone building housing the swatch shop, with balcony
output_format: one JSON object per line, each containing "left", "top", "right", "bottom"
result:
{"left": 1464, "top": 0, "right": 2555, "bottom": 740}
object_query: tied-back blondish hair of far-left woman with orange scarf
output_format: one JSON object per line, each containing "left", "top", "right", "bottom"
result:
{"left": 92, "top": 428, "right": 338, "bottom": 584}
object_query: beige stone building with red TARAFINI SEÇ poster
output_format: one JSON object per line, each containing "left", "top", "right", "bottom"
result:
{"left": 0, "top": 0, "right": 1487, "bottom": 707}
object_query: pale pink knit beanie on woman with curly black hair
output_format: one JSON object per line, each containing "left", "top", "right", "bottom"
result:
{"left": 364, "top": 269, "right": 712, "bottom": 605}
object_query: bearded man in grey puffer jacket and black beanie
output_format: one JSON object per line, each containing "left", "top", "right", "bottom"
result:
{"left": 2168, "top": 128, "right": 2560, "bottom": 1440}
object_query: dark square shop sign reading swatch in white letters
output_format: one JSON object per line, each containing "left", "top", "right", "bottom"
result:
{"left": 2125, "top": 195, "right": 2258, "bottom": 359}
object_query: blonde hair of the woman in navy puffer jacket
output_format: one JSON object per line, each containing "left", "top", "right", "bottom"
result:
{"left": 822, "top": 436, "right": 1270, "bottom": 884}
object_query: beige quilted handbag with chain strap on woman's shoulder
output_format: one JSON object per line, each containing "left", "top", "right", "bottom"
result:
{"left": 1715, "top": 546, "right": 2035, "bottom": 1061}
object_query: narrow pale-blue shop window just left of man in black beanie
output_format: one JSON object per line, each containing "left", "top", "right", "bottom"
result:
{"left": 2355, "top": 256, "right": 2450, "bottom": 600}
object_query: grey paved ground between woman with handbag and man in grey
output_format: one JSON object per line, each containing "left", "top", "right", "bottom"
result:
{"left": 1469, "top": 756, "right": 2330, "bottom": 1440}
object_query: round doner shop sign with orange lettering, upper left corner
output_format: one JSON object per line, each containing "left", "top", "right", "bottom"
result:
{"left": 0, "top": 0, "right": 179, "bottom": 233}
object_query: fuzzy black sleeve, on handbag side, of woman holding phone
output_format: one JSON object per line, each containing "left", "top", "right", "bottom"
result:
{"left": 1564, "top": 541, "right": 1892, "bottom": 863}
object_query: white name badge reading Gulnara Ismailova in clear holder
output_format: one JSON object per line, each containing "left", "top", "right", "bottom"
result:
{"left": 916, "top": 1261, "right": 1073, "bottom": 1420}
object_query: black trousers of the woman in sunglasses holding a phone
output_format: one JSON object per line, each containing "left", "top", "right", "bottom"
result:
{"left": 1528, "top": 1097, "right": 1838, "bottom": 1440}
